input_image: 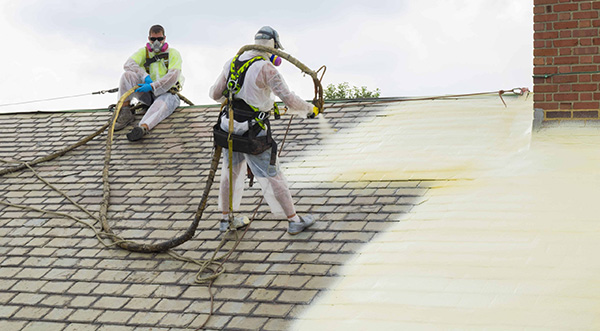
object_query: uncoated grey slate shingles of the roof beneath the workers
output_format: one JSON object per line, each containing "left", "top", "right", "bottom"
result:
{"left": 0, "top": 103, "right": 429, "bottom": 331}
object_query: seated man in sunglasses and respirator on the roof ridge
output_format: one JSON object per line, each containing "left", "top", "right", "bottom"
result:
{"left": 114, "top": 25, "right": 183, "bottom": 141}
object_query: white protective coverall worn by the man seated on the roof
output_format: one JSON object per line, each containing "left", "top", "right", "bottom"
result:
{"left": 119, "top": 47, "right": 183, "bottom": 130}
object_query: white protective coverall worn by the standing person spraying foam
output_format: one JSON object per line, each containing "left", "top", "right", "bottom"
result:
{"left": 210, "top": 51, "right": 313, "bottom": 218}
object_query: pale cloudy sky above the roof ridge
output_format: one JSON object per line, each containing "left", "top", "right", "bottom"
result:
{"left": 0, "top": 0, "right": 533, "bottom": 112}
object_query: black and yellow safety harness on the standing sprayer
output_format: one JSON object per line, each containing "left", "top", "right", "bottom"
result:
{"left": 213, "top": 55, "right": 278, "bottom": 165}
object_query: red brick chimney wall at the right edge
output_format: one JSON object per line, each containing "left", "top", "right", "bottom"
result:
{"left": 533, "top": 0, "right": 600, "bottom": 120}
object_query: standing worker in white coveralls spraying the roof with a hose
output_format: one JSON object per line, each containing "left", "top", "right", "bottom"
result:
{"left": 210, "top": 26, "right": 318, "bottom": 234}
